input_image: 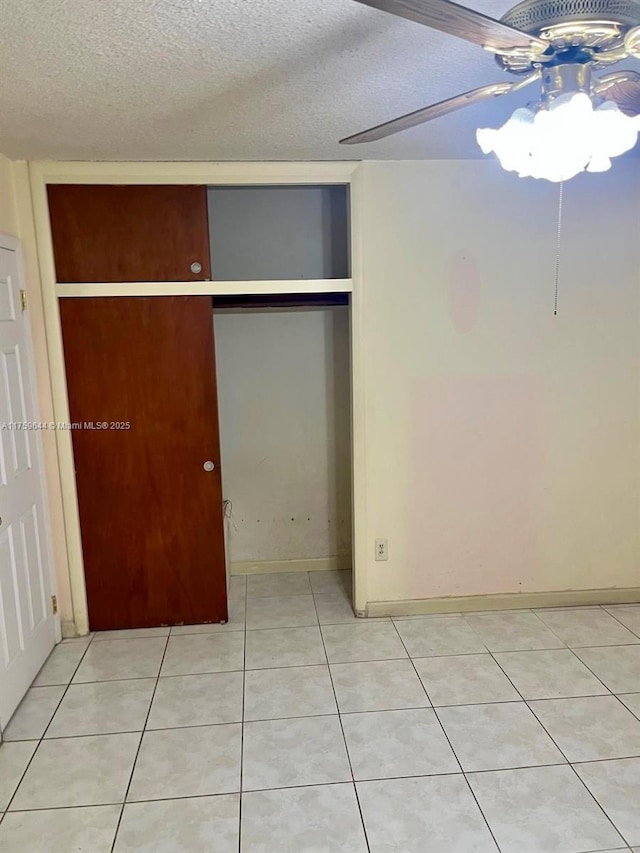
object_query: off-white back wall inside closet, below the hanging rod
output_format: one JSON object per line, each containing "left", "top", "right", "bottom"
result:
{"left": 215, "top": 306, "right": 351, "bottom": 562}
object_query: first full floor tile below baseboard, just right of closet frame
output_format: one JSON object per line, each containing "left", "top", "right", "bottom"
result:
{"left": 396, "top": 616, "right": 486, "bottom": 658}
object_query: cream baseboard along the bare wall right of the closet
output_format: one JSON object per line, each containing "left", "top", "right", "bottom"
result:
{"left": 366, "top": 587, "right": 640, "bottom": 616}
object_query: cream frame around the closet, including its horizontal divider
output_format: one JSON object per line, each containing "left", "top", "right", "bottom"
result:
{"left": 29, "top": 161, "right": 368, "bottom": 635}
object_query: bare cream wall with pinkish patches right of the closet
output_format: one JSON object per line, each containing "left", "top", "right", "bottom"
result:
{"left": 356, "top": 160, "right": 640, "bottom": 601}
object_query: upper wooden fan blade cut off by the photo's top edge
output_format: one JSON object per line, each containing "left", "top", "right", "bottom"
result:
{"left": 356, "top": 0, "right": 549, "bottom": 56}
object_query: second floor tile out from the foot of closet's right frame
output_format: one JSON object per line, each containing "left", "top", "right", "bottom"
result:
{"left": 331, "top": 660, "right": 429, "bottom": 714}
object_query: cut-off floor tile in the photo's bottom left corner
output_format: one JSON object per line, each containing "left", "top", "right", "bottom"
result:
{"left": 0, "top": 806, "right": 120, "bottom": 853}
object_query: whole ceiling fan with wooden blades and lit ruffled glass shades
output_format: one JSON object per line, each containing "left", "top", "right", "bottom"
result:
{"left": 340, "top": 0, "right": 640, "bottom": 181}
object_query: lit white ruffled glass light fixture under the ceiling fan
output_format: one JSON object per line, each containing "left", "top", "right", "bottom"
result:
{"left": 476, "top": 63, "right": 640, "bottom": 181}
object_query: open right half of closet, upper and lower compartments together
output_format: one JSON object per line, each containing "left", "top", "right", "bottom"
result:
{"left": 207, "top": 185, "right": 352, "bottom": 607}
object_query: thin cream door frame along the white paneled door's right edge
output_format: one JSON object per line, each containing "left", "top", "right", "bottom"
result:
{"left": 0, "top": 231, "right": 62, "bottom": 643}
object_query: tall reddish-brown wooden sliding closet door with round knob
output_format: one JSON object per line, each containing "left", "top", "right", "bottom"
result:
{"left": 60, "top": 296, "right": 227, "bottom": 630}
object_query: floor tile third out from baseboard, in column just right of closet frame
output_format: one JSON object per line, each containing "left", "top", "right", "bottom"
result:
{"left": 438, "top": 702, "right": 565, "bottom": 771}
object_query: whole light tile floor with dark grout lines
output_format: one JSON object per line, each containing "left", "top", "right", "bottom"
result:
{"left": 0, "top": 572, "right": 640, "bottom": 853}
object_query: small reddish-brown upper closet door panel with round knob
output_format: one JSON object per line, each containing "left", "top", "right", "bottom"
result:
{"left": 48, "top": 184, "right": 210, "bottom": 282}
